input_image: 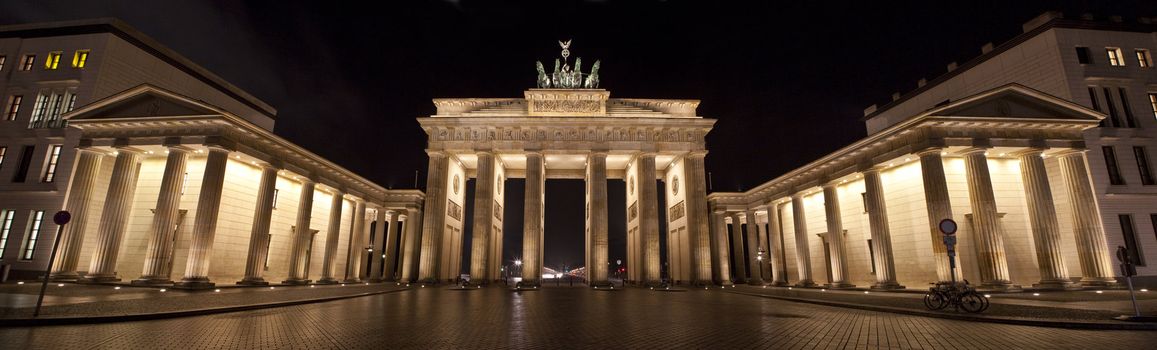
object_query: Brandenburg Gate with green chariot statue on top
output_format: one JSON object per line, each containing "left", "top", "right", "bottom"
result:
{"left": 404, "top": 42, "right": 727, "bottom": 286}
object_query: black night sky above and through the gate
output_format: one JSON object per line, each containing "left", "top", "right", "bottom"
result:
{"left": 0, "top": 0, "right": 1157, "bottom": 271}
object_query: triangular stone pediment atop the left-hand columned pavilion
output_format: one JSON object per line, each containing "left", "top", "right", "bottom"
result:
{"left": 67, "top": 87, "right": 221, "bottom": 120}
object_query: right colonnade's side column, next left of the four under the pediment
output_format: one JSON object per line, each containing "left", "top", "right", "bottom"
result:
{"left": 864, "top": 167, "right": 902, "bottom": 289}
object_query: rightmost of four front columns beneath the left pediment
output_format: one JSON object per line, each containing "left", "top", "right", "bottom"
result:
{"left": 177, "top": 146, "right": 229, "bottom": 288}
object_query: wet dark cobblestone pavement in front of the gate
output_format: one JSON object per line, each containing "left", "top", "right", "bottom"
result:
{"left": 0, "top": 288, "right": 1157, "bottom": 349}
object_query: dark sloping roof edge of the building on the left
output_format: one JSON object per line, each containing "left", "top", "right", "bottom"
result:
{"left": 0, "top": 17, "right": 278, "bottom": 119}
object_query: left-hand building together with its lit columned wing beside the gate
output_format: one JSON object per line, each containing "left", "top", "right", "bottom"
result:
{"left": 0, "top": 20, "right": 423, "bottom": 288}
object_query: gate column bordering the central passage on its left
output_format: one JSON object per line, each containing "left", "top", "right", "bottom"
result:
{"left": 522, "top": 151, "right": 546, "bottom": 286}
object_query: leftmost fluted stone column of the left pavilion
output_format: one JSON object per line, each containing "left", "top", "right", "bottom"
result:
{"left": 51, "top": 148, "right": 104, "bottom": 281}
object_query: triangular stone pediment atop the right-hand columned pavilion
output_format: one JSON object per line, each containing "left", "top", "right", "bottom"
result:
{"left": 930, "top": 85, "right": 1103, "bottom": 120}
